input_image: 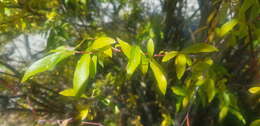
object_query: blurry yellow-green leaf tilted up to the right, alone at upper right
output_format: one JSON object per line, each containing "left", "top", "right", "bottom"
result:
{"left": 218, "top": 19, "right": 238, "bottom": 37}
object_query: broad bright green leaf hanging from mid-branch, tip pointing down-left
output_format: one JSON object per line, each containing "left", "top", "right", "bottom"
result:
{"left": 126, "top": 46, "right": 141, "bottom": 77}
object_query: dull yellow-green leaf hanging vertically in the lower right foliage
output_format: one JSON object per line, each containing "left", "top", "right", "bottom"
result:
{"left": 205, "top": 79, "right": 216, "bottom": 103}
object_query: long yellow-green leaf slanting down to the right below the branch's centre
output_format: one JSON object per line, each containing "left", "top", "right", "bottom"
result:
{"left": 150, "top": 59, "right": 167, "bottom": 95}
